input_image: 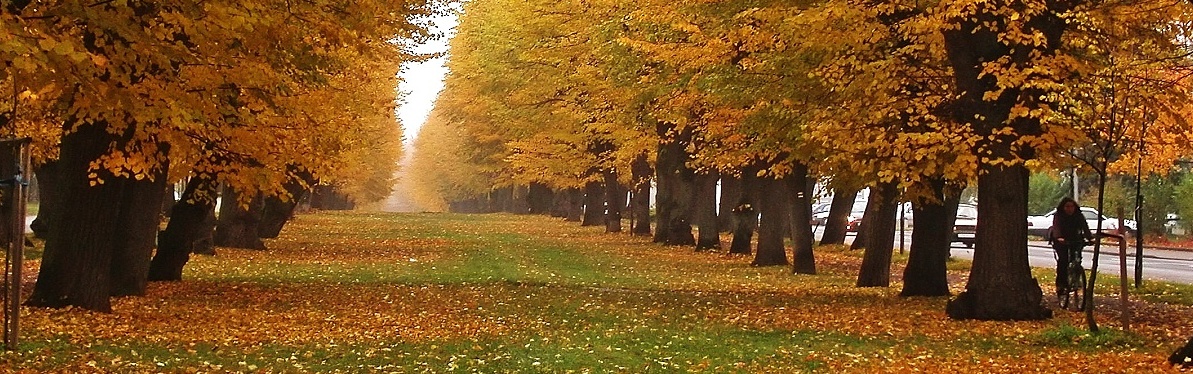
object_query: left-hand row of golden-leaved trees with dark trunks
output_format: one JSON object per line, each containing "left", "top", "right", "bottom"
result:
{"left": 0, "top": 0, "right": 445, "bottom": 311}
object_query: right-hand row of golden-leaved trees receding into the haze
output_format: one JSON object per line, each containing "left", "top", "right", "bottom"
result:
{"left": 410, "top": 0, "right": 1193, "bottom": 320}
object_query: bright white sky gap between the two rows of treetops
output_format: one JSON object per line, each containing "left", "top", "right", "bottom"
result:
{"left": 397, "top": 14, "right": 456, "bottom": 142}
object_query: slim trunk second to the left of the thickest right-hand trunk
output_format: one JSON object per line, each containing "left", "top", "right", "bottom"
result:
{"left": 858, "top": 183, "right": 898, "bottom": 287}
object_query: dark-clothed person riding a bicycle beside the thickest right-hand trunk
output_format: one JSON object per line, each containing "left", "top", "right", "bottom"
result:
{"left": 1049, "top": 197, "right": 1094, "bottom": 296}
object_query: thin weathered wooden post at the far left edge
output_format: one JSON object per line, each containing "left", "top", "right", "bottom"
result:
{"left": 0, "top": 139, "right": 30, "bottom": 350}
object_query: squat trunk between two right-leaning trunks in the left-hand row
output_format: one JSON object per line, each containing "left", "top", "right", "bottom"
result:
{"left": 212, "top": 186, "right": 265, "bottom": 250}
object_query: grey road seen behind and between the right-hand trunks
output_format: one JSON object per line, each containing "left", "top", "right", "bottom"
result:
{"left": 815, "top": 225, "right": 1193, "bottom": 284}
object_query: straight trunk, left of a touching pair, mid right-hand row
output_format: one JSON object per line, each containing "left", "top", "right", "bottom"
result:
{"left": 750, "top": 174, "right": 791, "bottom": 266}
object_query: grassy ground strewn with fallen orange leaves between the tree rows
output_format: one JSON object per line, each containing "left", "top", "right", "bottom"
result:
{"left": 0, "top": 213, "right": 1193, "bottom": 373}
